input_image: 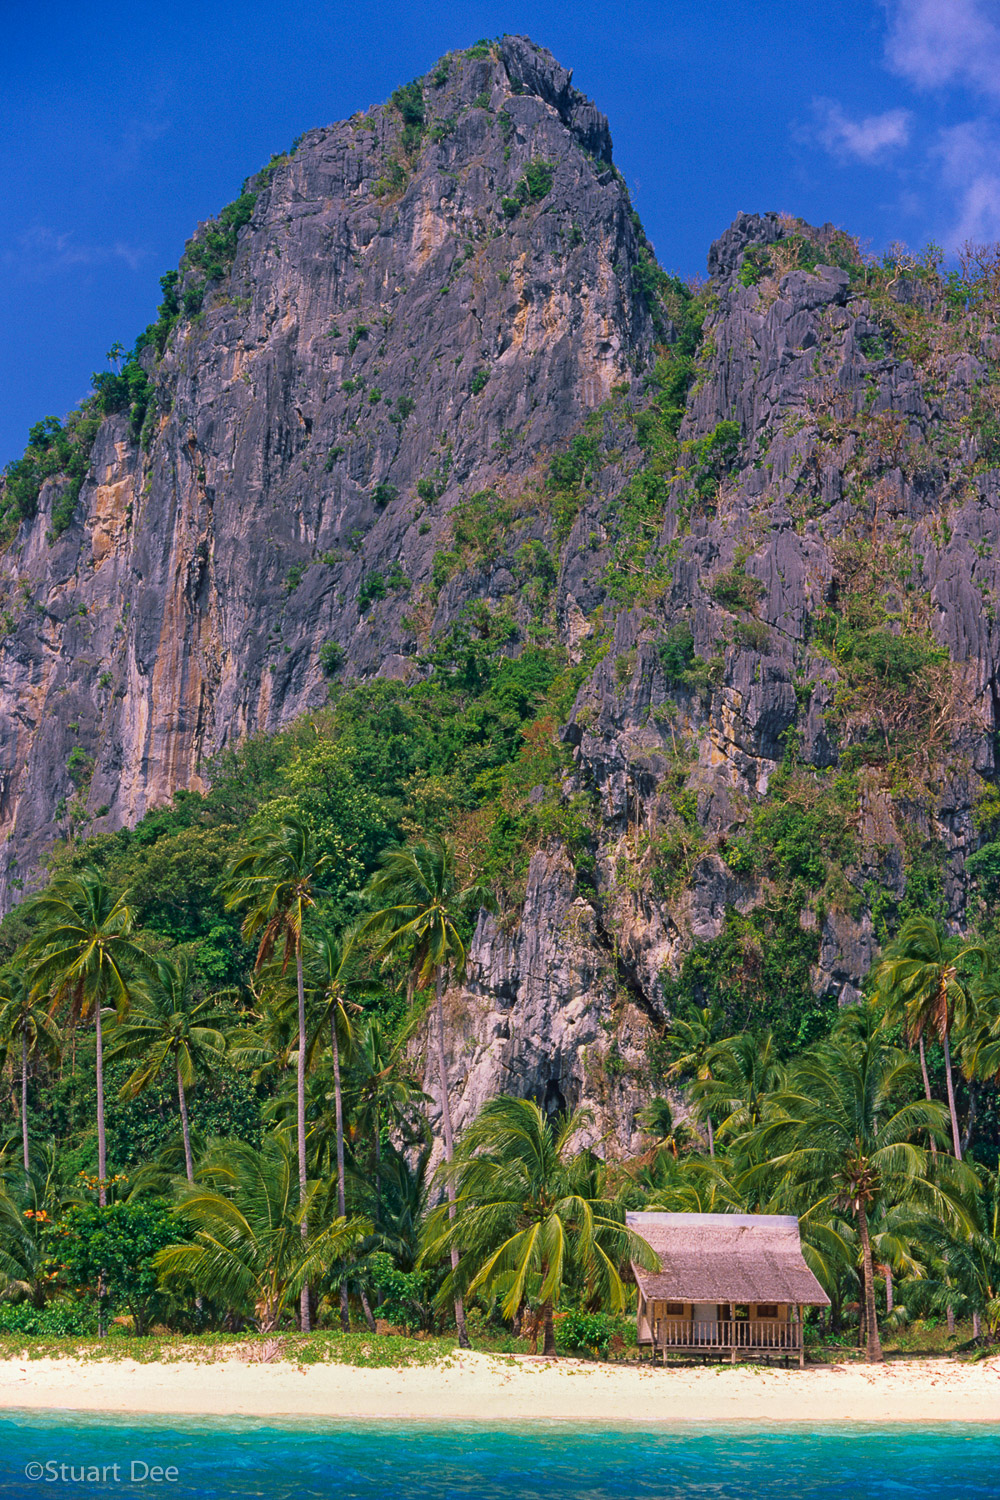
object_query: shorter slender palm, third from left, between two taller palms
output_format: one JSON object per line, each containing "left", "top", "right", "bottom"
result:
{"left": 108, "top": 959, "right": 226, "bottom": 1182}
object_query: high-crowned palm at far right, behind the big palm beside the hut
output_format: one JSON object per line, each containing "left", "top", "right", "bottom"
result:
{"left": 874, "top": 917, "right": 984, "bottom": 1161}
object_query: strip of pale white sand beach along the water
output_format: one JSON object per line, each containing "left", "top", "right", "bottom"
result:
{"left": 0, "top": 1350, "right": 1000, "bottom": 1422}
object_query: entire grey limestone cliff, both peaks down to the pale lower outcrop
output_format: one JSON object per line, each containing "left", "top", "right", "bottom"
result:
{"left": 0, "top": 38, "right": 1000, "bottom": 1146}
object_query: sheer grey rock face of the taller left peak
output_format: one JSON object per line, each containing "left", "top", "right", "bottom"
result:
{"left": 0, "top": 39, "right": 654, "bottom": 902}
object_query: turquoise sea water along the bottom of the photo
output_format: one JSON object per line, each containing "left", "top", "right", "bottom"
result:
{"left": 0, "top": 1412, "right": 1000, "bottom": 1500}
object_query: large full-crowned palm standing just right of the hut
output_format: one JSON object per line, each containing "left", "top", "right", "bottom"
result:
{"left": 748, "top": 1010, "right": 969, "bottom": 1361}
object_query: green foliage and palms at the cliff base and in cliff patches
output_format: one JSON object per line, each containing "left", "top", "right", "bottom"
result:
{"left": 0, "top": 105, "right": 1000, "bottom": 1358}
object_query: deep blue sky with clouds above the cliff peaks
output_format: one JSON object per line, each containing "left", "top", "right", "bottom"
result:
{"left": 0, "top": 0, "right": 1000, "bottom": 464}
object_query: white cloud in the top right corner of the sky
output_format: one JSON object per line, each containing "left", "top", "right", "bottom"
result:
{"left": 883, "top": 0, "right": 1000, "bottom": 99}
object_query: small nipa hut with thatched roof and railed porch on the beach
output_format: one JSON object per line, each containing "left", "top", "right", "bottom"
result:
{"left": 627, "top": 1214, "right": 829, "bottom": 1364}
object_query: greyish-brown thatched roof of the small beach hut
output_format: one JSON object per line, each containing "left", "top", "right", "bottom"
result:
{"left": 625, "top": 1214, "right": 831, "bottom": 1307}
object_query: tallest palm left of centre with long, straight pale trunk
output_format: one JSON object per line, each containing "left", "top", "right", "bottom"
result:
{"left": 223, "top": 818, "right": 328, "bottom": 1334}
